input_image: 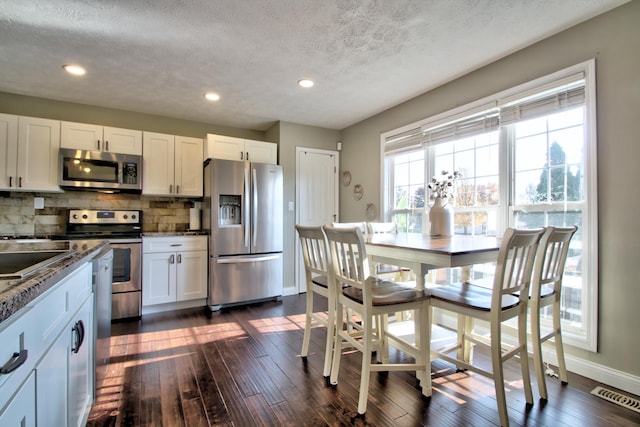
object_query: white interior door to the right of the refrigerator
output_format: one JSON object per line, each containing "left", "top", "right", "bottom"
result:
{"left": 295, "top": 147, "right": 339, "bottom": 292}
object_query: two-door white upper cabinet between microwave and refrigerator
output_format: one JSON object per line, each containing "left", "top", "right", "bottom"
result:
{"left": 142, "top": 132, "right": 203, "bottom": 197}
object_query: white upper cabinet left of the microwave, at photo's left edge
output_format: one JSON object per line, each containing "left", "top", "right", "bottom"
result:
{"left": 0, "top": 114, "right": 60, "bottom": 192}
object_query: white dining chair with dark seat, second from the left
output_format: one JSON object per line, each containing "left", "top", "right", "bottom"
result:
{"left": 323, "top": 226, "right": 431, "bottom": 414}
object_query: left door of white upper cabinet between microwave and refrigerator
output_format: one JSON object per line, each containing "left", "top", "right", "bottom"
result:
{"left": 142, "top": 132, "right": 175, "bottom": 196}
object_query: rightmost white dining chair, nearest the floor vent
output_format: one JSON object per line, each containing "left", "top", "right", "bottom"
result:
{"left": 529, "top": 226, "right": 578, "bottom": 400}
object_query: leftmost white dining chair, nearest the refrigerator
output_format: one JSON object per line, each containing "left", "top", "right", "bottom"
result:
{"left": 296, "top": 225, "right": 336, "bottom": 378}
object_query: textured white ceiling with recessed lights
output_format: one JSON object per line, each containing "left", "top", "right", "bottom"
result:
{"left": 0, "top": 0, "right": 626, "bottom": 130}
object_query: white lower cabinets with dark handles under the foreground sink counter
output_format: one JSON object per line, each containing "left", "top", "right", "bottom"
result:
{"left": 0, "top": 264, "right": 94, "bottom": 426}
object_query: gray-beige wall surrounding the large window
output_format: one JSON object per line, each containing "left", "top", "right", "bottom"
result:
{"left": 340, "top": 1, "right": 640, "bottom": 382}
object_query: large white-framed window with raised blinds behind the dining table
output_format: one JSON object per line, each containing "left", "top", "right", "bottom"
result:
{"left": 381, "top": 60, "right": 597, "bottom": 350}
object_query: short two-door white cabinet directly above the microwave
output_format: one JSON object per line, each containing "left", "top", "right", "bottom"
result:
{"left": 60, "top": 122, "right": 142, "bottom": 156}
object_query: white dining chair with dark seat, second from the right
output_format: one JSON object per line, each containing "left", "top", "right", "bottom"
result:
{"left": 427, "top": 228, "right": 544, "bottom": 426}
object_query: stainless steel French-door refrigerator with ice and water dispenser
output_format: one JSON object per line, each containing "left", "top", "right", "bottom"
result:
{"left": 202, "top": 159, "right": 283, "bottom": 311}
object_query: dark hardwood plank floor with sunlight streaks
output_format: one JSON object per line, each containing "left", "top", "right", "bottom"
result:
{"left": 87, "top": 295, "right": 640, "bottom": 427}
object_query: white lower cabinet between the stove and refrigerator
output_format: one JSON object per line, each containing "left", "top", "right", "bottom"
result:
{"left": 142, "top": 236, "right": 208, "bottom": 307}
